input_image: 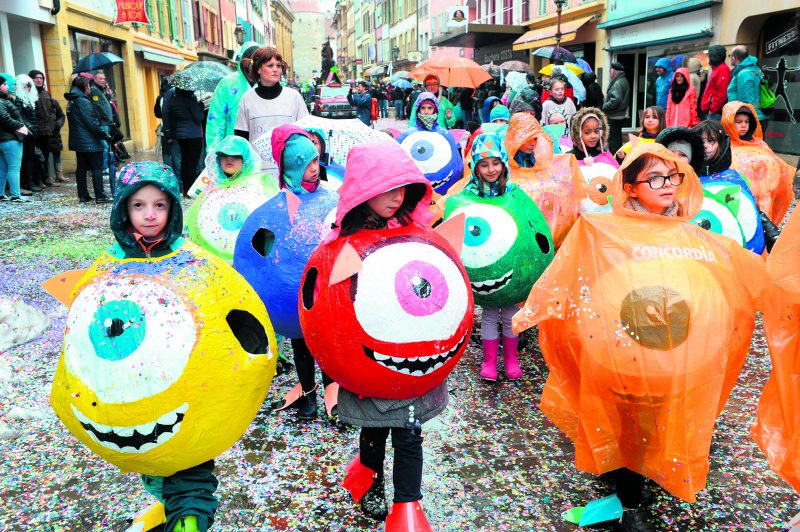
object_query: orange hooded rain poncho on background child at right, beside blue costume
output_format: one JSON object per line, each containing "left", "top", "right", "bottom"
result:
{"left": 722, "top": 102, "right": 794, "bottom": 224}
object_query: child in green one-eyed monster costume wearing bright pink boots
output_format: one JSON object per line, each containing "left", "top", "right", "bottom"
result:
{"left": 445, "top": 133, "right": 553, "bottom": 382}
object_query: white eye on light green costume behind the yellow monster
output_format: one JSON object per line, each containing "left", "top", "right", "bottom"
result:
{"left": 197, "top": 186, "right": 269, "bottom": 256}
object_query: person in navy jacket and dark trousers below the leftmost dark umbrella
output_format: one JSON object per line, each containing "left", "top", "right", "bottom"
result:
{"left": 64, "top": 76, "right": 111, "bottom": 203}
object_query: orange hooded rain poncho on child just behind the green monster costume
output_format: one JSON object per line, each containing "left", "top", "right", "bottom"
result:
{"left": 506, "top": 113, "right": 586, "bottom": 249}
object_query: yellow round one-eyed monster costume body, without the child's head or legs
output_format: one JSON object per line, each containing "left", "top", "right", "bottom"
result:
{"left": 50, "top": 242, "right": 277, "bottom": 476}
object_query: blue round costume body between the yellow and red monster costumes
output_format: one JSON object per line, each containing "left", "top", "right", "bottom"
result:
{"left": 233, "top": 190, "right": 339, "bottom": 338}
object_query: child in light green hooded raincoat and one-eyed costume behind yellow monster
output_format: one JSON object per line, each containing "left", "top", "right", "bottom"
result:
{"left": 186, "top": 135, "right": 278, "bottom": 263}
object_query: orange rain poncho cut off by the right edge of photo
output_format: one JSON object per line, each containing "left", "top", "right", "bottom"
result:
{"left": 750, "top": 210, "right": 800, "bottom": 491}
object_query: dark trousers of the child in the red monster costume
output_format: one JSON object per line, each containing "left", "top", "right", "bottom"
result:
{"left": 358, "top": 427, "right": 422, "bottom": 502}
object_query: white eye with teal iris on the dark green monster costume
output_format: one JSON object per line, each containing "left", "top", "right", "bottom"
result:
{"left": 448, "top": 203, "right": 518, "bottom": 269}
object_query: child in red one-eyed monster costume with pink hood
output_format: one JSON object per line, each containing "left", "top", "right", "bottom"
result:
{"left": 310, "top": 142, "right": 472, "bottom": 532}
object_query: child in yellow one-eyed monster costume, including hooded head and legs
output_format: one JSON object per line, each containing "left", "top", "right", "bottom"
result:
{"left": 51, "top": 162, "right": 276, "bottom": 532}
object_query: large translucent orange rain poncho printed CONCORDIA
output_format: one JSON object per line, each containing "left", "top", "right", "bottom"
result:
{"left": 514, "top": 144, "right": 763, "bottom": 502}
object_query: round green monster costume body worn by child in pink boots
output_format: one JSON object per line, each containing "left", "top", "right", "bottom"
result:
{"left": 445, "top": 186, "right": 554, "bottom": 307}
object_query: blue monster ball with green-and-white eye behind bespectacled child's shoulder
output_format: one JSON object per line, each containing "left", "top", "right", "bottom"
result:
{"left": 692, "top": 170, "right": 765, "bottom": 255}
